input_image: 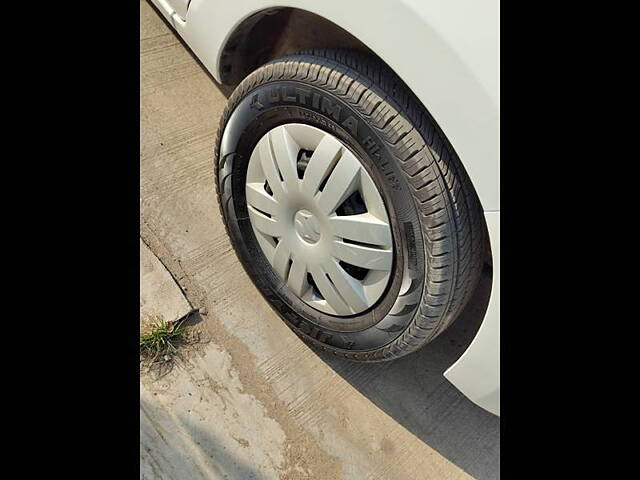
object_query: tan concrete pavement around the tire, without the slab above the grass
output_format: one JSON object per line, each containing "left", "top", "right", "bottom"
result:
{"left": 140, "top": 1, "right": 500, "bottom": 480}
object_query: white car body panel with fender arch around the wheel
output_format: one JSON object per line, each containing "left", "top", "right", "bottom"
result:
{"left": 152, "top": 0, "right": 500, "bottom": 415}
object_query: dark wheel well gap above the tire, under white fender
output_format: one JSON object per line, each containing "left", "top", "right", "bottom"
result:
{"left": 220, "top": 7, "right": 379, "bottom": 87}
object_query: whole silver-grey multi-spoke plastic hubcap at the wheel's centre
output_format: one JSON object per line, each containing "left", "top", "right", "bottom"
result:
{"left": 245, "top": 124, "right": 394, "bottom": 316}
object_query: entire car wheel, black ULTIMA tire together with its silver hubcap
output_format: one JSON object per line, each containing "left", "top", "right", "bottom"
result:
{"left": 215, "top": 50, "right": 485, "bottom": 361}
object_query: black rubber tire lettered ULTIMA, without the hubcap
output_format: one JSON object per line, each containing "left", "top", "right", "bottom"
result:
{"left": 215, "top": 49, "right": 486, "bottom": 361}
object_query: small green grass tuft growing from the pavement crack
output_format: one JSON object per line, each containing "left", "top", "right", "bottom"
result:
{"left": 140, "top": 318, "right": 189, "bottom": 363}
